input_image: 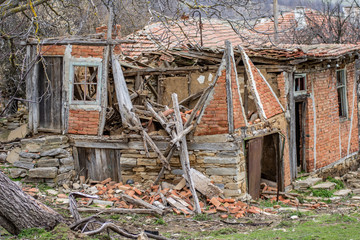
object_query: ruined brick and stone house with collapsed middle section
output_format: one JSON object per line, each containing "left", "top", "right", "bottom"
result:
{"left": 21, "top": 21, "right": 360, "bottom": 198}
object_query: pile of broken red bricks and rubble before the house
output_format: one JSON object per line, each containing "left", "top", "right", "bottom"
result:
{"left": 23, "top": 175, "right": 263, "bottom": 218}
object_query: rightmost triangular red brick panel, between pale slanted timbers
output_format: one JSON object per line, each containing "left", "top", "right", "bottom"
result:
{"left": 249, "top": 61, "right": 283, "bottom": 118}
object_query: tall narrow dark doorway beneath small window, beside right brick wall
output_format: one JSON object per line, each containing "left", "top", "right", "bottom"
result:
{"left": 295, "top": 101, "right": 306, "bottom": 172}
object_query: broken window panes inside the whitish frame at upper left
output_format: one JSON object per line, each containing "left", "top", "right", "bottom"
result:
{"left": 72, "top": 65, "right": 99, "bottom": 102}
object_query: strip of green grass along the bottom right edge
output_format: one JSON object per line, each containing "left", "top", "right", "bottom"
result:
{"left": 173, "top": 213, "right": 360, "bottom": 240}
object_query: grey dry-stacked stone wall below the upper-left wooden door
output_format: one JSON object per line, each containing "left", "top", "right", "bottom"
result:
{"left": 9, "top": 136, "right": 75, "bottom": 186}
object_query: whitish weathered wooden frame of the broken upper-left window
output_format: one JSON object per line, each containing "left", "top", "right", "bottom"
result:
{"left": 69, "top": 61, "right": 102, "bottom": 106}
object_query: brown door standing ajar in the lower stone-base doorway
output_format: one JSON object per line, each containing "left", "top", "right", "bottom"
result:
{"left": 247, "top": 137, "right": 263, "bottom": 200}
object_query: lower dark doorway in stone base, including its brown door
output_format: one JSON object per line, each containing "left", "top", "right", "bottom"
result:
{"left": 245, "top": 133, "right": 284, "bottom": 199}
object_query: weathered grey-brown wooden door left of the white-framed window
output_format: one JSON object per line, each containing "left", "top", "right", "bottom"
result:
{"left": 38, "top": 57, "right": 63, "bottom": 132}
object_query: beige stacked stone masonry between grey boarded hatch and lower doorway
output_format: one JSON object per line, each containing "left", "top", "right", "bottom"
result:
{"left": 116, "top": 143, "right": 246, "bottom": 197}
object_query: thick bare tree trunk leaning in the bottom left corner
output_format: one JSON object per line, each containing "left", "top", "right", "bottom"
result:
{"left": 0, "top": 171, "right": 64, "bottom": 234}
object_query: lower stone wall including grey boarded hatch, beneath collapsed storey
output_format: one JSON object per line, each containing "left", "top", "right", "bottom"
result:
{"left": 74, "top": 140, "right": 246, "bottom": 197}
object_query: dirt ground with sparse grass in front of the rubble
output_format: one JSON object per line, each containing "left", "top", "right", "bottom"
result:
{"left": 0, "top": 185, "right": 360, "bottom": 239}
